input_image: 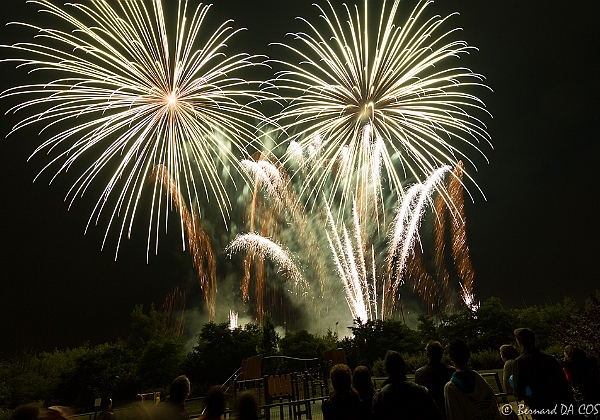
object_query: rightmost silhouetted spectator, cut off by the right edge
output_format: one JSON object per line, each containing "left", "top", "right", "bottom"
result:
{"left": 562, "top": 346, "right": 600, "bottom": 419}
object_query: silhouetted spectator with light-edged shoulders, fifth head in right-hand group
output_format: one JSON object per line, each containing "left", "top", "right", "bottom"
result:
{"left": 444, "top": 338, "right": 503, "bottom": 420}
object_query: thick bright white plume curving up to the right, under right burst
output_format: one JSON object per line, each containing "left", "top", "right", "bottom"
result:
{"left": 388, "top": 166, "right": 452, "bottom": 314}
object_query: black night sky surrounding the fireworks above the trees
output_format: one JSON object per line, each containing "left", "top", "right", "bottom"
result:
{"left": 0, "top": 0, "right": 600, "bottom": 357}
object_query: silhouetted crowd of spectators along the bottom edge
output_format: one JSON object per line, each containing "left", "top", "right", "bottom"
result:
{"left": 11, "top": 328, "right": 600, "bottom": 420}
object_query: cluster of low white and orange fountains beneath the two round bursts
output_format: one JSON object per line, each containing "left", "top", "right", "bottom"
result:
{"left": 227, "top": 152, "right": 473, "bottom": 322}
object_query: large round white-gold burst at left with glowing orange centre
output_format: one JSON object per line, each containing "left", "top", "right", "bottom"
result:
{"left": 0, "top": 0, "right": 274, "bottom": 257}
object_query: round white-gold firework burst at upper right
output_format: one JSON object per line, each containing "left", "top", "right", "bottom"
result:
{"left": 273, "top": 0, "right": 489, "bottom": 209}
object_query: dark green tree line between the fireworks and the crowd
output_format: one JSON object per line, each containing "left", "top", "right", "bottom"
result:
{"left": 0, "top": 291, "right": 600, "bottom": 414}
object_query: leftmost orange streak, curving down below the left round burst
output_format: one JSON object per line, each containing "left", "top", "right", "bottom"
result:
{"left": 149, "top": 165, "right": 217, "bottom": 321}
